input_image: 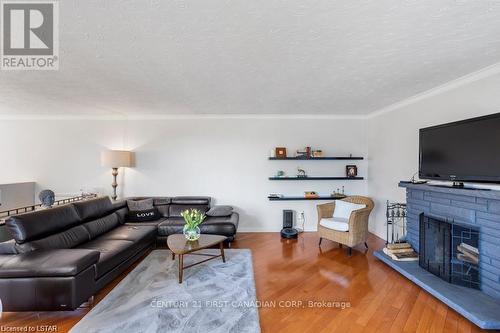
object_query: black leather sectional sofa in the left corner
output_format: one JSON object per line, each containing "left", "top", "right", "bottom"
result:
{"left": 0, "top": 197, "right": 239, "bottom": 311}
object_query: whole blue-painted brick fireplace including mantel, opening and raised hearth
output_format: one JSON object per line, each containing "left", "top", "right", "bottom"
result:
{"left": 373, "top": 182, "right": 500, "bottom": 329}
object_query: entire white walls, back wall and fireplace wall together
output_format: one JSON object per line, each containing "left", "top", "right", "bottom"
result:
{"left": 0, "top": 68, "right": 500, "bottom": 237}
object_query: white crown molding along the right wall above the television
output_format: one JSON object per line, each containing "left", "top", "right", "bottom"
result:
{"left": 365, "top": 62, "right": 500, "bottom": 119}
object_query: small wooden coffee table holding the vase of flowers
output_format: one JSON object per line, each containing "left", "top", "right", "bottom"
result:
{"left": 167, "top": 234, "right": 227, "bottom": 283}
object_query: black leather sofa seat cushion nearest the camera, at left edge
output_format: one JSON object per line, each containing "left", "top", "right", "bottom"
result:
{"left": 0, "top": 249, "right": 99, "bottom": 278}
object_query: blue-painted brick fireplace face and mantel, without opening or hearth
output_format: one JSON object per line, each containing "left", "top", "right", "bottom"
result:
{"left": 400, "top": 183, "right": 500, "bottom": 299}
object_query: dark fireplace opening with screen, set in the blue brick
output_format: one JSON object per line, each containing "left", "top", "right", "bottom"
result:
{"left": 419, "top": 214, "right": 481, "bottom": 289}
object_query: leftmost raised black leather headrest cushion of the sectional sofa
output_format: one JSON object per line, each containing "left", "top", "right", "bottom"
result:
{"left": 5, "top": 205, "right": 81, "bottom": 244}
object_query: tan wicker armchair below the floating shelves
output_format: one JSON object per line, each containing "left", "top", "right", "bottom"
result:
{"left": 317, "top": 196, "right": 374, "bottom": 255}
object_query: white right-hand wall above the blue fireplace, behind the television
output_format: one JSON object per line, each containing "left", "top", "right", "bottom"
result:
{"left": 368, "top": 68, "right": 500, "bottom": 238}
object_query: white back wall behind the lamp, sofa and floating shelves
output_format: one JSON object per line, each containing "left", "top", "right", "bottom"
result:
{"left": 0, "top": 117, "right": 367, "bottom": 231}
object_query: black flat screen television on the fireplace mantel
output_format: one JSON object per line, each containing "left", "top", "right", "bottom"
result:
{"left": 419, "top": 113, "right": 500, "bottom": 183}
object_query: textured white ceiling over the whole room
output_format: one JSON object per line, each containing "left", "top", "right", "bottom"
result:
{"left": 0, "top": 0, "right": 500, "bottom": 115}
